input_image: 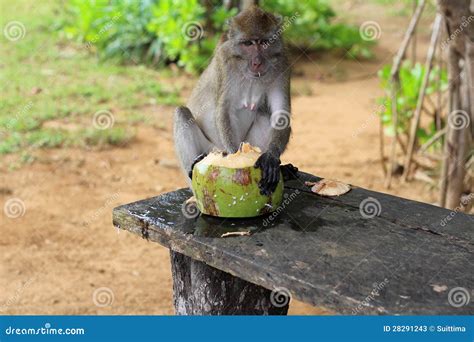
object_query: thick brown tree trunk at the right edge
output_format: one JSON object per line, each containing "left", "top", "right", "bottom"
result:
{"left": 438, "top": 0, "right": 474, "bottom": 209}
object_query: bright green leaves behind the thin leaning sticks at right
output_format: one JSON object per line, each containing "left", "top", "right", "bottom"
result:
{"left": 378, "top": 61, "right": 448, "bottom": 143}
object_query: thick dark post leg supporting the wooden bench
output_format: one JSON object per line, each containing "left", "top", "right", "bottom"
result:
{"left": 170, "top": 250, "right": 289, "bottom": 315}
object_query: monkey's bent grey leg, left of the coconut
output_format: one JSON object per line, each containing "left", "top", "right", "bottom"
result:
{"left": 174, "top": 107, "right": 213, "bottom": 182}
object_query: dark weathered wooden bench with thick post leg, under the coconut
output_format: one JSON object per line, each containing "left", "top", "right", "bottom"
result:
{"left": 113, "top": 173, "right": 474, "bottom": 315}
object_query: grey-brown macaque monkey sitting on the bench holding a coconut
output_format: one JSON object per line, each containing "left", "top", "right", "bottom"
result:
{"left": 174, "top": 6, "right": 297, "bottom": 195}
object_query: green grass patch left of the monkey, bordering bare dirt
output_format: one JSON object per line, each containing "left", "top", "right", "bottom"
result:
{"left": 0, "top": 0, "right": 181, "bottom": 156}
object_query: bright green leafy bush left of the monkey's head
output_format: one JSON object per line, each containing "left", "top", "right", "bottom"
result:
{"left": 64, "top": 0, "right": 236, "bottom": 72}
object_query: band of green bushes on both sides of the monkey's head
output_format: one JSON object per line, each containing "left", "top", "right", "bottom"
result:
{"left": 64, "top": 0, "right": 373, "bottom": 72}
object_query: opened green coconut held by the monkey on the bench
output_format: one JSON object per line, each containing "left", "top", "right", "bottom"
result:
{"left": 192, "top": 144, "right": 283, "bottom": 217}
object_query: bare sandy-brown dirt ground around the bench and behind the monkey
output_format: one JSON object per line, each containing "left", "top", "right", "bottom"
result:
{"left": 0, "top": 3, "right": 436, "bottom": 315}
